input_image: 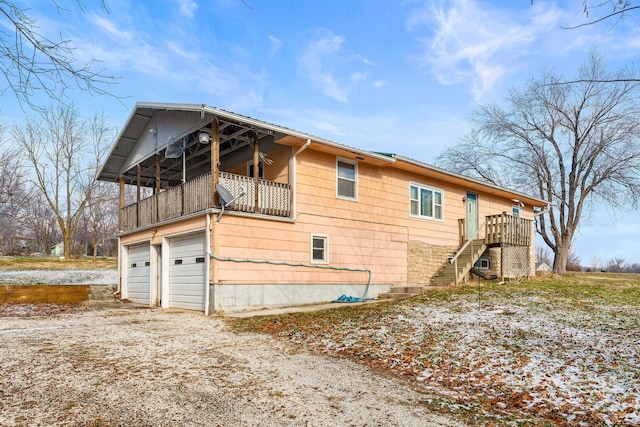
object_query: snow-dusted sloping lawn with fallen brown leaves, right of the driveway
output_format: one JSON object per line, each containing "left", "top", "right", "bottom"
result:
{"left": 229, "top": 273, "right": 640, "bottom": 426}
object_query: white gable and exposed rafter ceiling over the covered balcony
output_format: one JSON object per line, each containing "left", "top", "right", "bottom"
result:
{"left": 97, "top": 106, "right": 285, "bottom": 188}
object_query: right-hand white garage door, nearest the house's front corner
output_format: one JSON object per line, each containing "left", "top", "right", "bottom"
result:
{"left": 169, "top": 233, "right": 206, "bottom": 311}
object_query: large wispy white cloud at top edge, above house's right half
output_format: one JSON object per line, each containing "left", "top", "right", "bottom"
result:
{"left": 407, "top": 0, "right": 558, "bottom": 100}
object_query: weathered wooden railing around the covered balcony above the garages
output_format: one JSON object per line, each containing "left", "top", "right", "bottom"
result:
{"left": 120, "top": 172, "right": 291, "bottom": 231}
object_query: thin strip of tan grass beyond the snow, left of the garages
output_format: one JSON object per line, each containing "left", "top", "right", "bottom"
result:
{"left": 0, "top": 256, "right": 118, "bottom": 271}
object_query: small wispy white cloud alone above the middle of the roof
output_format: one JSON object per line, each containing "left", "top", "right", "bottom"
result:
{"left": 300, "top": 30, "right": 373, "bottom": 103}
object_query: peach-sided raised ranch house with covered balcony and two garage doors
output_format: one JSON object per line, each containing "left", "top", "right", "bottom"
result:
{"left": 98, "top": 103, "right": 547, "bottom": 314}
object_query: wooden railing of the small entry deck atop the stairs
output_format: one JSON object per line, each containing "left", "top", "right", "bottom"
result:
{"left": 458, "top": 213, "right": 533, "bottom": 246}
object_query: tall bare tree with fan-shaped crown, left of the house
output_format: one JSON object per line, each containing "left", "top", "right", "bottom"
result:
{"left": 13, "top": 104, "right": 109, "bottom": 257}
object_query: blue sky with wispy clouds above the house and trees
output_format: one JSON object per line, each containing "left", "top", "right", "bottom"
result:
{"left": 1, "top": 0, "right": 640, "bottom": 265}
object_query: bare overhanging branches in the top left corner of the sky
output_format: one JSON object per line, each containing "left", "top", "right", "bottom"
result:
{"left": 0, "top": 0, "right": 117, "bottom": 108}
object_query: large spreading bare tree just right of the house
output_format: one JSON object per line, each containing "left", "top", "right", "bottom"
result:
{"left": 438, "top": 52, "right": 640, "bottom": 274}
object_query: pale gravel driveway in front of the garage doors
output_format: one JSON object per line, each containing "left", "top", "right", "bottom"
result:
{"left": 0, "top": 305, "right": 461, "bottom": 426}
